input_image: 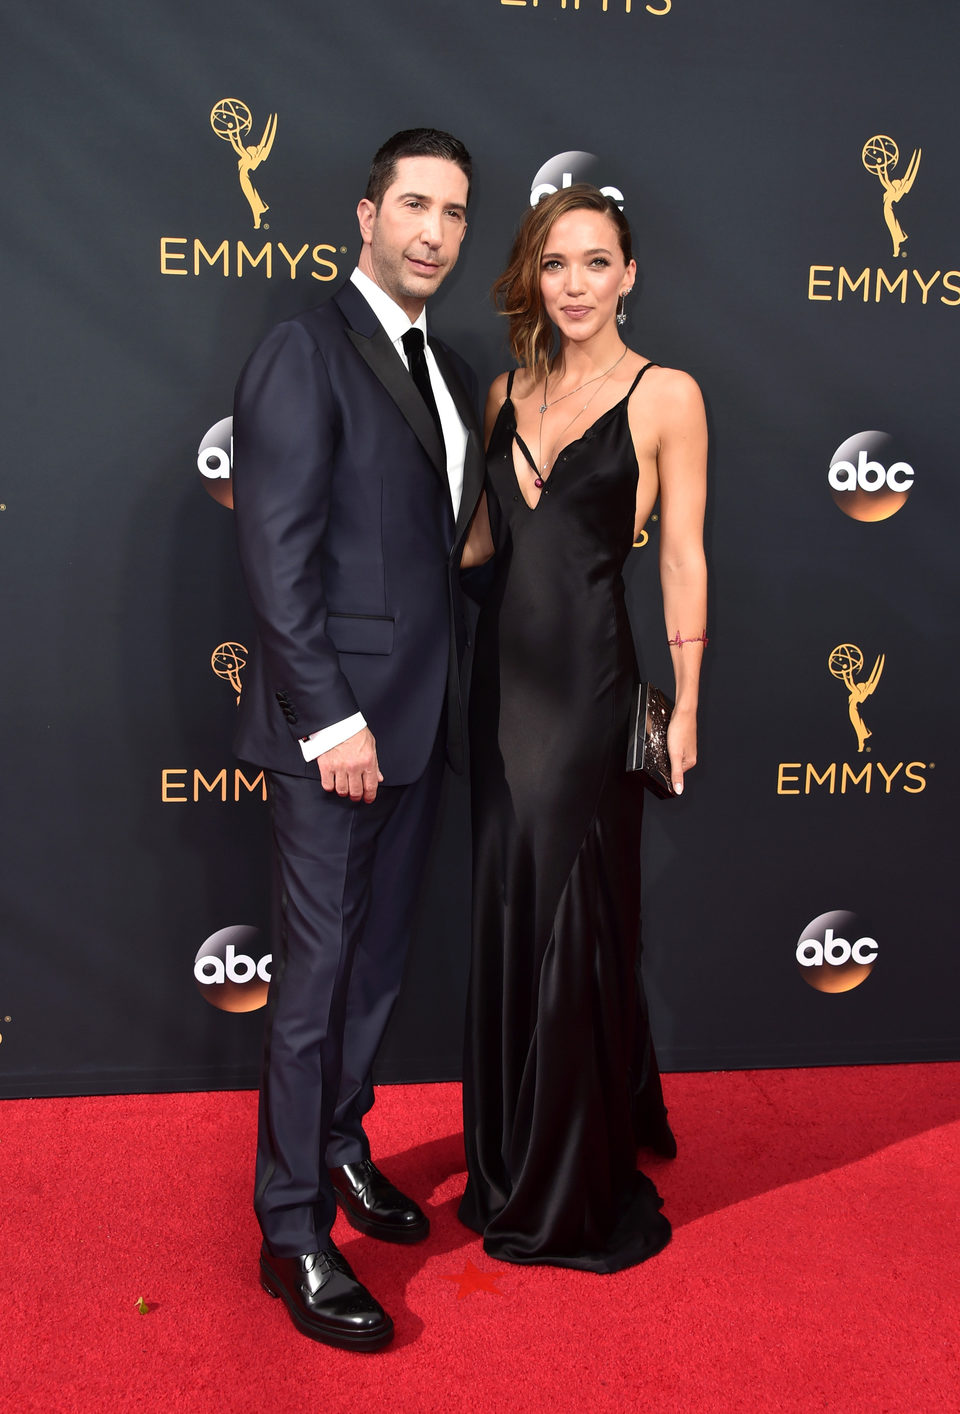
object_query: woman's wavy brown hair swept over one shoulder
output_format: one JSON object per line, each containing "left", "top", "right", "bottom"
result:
{"left": 491, "top": 182, "right": 633, "bottom": 379}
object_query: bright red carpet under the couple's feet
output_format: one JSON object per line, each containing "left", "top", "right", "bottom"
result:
{"left": 0, "top": 1065, "right": 960, "bottom": 1414}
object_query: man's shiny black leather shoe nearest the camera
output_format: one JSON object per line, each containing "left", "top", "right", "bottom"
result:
{"left": 260, "top": 1244, "right": 393, "bottom": 1350}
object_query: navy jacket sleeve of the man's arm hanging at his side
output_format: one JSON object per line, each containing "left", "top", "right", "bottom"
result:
{"left": 233, "top": 321, "right": 358, "bottom": 740}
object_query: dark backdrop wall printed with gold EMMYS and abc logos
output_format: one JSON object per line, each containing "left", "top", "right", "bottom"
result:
{"left": 0, "top": 0, "right": 960, "bottom": 1094}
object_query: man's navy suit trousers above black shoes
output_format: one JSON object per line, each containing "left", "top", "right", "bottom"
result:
{"left": 254, "top": 723, "right": 444, "bottom": 1257}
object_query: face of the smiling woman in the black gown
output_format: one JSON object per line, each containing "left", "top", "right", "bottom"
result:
{"left": 540, "top": 209, "right": 636, "bottom": 342}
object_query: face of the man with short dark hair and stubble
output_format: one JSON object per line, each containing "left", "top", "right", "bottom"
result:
{"left": 356, "top": 157, "right": 468, "bottom": 321}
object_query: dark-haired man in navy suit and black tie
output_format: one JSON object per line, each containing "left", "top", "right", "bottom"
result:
{"left": 233, "top": 129, "right": 482, "bottom": 1350}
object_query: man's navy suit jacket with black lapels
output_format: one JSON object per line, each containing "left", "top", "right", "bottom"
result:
{"left": 233, "top": 275, "right": 484, "bottom": 785}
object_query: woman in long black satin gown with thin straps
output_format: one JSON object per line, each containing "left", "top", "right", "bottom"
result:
{"left": 459, "top": 185, "right": 707, "bottom": 1271}
